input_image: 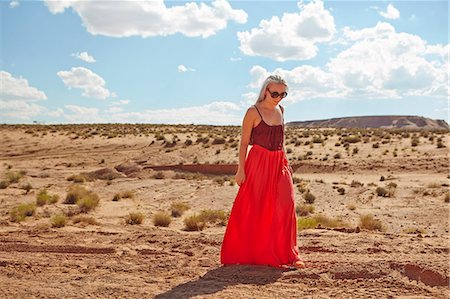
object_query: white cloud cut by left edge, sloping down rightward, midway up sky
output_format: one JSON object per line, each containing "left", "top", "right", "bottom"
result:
{"left": 0, "top": 71, "right": 47, "bottom": 100}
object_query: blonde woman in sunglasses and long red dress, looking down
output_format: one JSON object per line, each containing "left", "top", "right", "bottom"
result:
{"left": 220, "top": 75, "right": 305, "bottom": 268}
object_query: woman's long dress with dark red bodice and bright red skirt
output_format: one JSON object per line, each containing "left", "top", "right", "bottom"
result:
{"left": 220, "top": 106, "right": 301, "bottom": 267}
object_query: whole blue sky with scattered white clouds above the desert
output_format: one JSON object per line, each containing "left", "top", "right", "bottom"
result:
{"left": 0, "top": 0, "right": 450, "bottom": 125}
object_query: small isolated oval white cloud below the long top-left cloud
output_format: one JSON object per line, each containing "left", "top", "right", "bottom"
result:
{"left": 57, "top": 67, "right": 111, "bottom": 99}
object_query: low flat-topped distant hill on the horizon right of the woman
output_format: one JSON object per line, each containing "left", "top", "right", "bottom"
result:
{"left": 286, "top": 115, "right": 450, "bottom": 130}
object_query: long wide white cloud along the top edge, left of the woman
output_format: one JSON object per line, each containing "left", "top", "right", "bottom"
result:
{"left": 45, "top": 0, "right": 247, "bottom": 38}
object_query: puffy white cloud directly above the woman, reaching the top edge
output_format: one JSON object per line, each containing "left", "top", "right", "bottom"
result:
{"left": 237, "top": 1, "right": 336, "bottom": 61}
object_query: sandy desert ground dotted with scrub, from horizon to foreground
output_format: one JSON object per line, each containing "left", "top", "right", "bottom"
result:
{"left": 0, "top": 124, "right": 450, "bottom": 298}
